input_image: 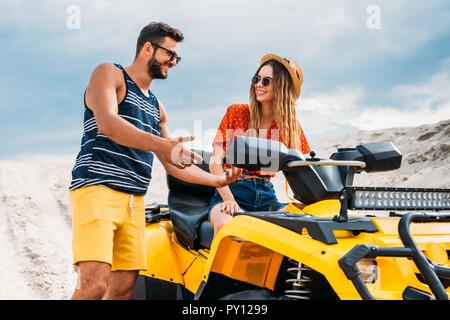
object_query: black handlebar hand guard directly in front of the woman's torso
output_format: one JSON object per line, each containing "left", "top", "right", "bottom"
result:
{"left": 223, "top": 136, "right": 305, "bottom": 172}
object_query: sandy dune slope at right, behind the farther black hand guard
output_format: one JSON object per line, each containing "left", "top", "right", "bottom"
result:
{"left": 313, "top": 120, "right": 450, "bottom": 188}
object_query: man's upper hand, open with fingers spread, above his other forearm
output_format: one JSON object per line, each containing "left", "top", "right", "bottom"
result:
{"left": 155, "top": 136, "right": 203, "bottom": 169}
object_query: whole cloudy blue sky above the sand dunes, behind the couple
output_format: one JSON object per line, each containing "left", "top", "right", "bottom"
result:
{"left": 0, "top": 0, "right": 450, "bottom": 159}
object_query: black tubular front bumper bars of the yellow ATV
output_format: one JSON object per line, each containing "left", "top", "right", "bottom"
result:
{"left": 339, "top": 213, "right": 450, "bottom": 300}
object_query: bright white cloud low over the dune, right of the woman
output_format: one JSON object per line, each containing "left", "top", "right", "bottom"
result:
{"left": 297, "top": 68, "right": 450, "bottom": 136}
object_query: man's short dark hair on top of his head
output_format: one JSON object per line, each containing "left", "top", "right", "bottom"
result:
{"left": 136, "top": 22, "right": 184, "bottom": 57}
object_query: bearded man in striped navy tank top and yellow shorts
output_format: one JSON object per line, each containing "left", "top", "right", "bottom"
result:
{"left": 70, "top": 22, "right": 241, "bottom": 299}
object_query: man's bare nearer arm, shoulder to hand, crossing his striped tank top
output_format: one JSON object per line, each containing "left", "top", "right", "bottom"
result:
{"left": 86, "top": 63, "right": 199, "bottom": 168}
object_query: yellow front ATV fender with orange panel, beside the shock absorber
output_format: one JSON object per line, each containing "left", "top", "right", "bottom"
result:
{"left": 197, "top": 215, "right": 358, "bottom": 297}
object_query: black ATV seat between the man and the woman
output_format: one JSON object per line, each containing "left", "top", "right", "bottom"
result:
{"left": 167, "top": 150, "right": 216, "bottom": 250}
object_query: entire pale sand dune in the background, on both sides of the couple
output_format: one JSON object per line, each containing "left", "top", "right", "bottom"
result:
{"left": 0, "top": 120, "right": 450, "bottom": 299}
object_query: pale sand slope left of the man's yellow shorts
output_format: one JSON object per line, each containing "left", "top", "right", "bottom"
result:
{"left": 0, "top": 161, "right": 76, "bottom": 299}
